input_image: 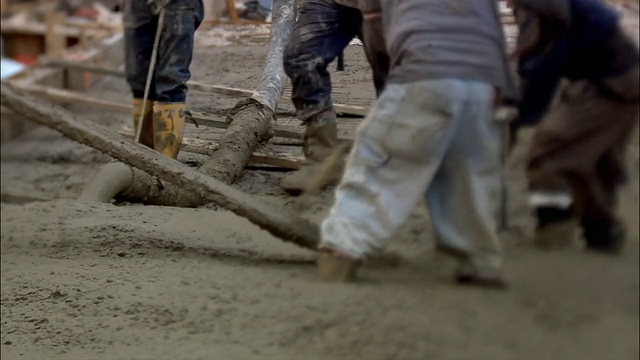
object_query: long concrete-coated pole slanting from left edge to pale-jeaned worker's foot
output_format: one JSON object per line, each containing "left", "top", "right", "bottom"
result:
{"left": 0, "top": 83, "right": 320, "bottom": 250}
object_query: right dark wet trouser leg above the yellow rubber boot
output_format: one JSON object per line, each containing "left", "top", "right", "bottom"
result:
{"left": 155, "top": 0, "right": 204, "bottom": 103}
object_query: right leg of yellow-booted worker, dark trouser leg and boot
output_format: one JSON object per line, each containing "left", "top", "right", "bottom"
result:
{"left": 153, "top": 0, "right": 204, "bottom": 158}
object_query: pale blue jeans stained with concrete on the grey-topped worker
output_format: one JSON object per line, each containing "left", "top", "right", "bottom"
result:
{"left": 321, "top": 79, "right": 501, "bottom": 273}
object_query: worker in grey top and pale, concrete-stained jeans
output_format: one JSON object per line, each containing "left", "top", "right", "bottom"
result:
{"left": 318, "top": 0, "right": 517, "bottom": 287}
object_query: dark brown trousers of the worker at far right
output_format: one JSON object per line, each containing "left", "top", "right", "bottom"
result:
{"left": 528, "top": 67, "right": 639, "bottom": 241}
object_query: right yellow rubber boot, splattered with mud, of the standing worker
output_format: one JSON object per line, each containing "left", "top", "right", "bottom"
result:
{"left": 153, "top": 103, "right": 186, "bottom": 159}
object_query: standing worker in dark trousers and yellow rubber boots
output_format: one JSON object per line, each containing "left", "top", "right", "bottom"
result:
{"left": 124, "top": 0, "right": 204, "bottom": 158}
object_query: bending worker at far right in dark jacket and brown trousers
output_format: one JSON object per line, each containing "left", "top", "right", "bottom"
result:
{"left": 513, "top": 0, "right": 640, "bottom": 253}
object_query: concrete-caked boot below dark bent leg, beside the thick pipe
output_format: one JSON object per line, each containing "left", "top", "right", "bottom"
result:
{"left": 280, "top": 111, "right": 341, "bottom": 196}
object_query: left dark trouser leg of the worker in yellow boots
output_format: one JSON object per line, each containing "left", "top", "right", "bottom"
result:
{"left": 123, "top": 1, "right": 158, "bottom": 100}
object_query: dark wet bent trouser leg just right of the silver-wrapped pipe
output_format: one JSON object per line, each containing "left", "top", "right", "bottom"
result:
{"left": 284, "top": 0, "right": 362, "bottom": 120}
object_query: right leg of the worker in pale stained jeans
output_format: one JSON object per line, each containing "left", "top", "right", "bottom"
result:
{"left": 426, "top": 83, "right": 502, "bottom": 282}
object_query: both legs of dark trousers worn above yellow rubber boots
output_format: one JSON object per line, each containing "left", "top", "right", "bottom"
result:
{"left": 124, "top": 0, "right": 204, "bottom": 103}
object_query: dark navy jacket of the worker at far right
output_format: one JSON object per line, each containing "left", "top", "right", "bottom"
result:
{"left": 514, "top": 0, "right": 640, "bottom": 125}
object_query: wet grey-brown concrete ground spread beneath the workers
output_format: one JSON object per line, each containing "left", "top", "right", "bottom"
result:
{"left": 0, "top": 11, "right": 640, "bottom": 359}
